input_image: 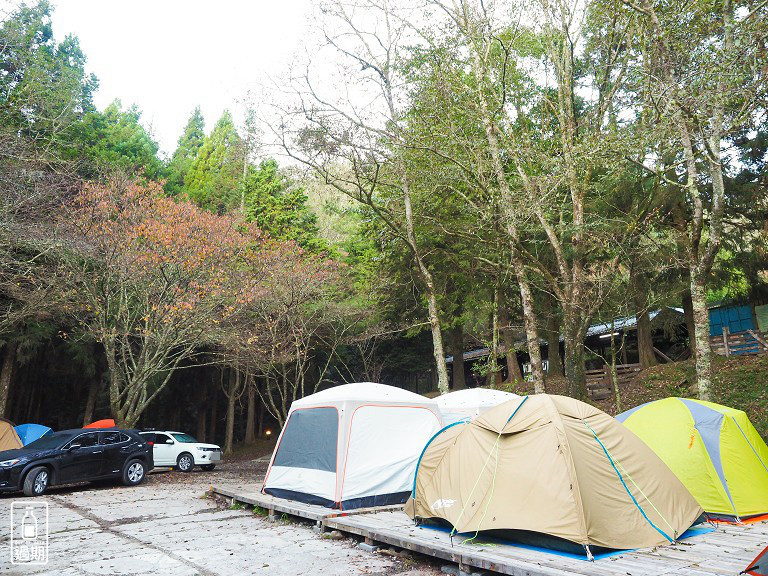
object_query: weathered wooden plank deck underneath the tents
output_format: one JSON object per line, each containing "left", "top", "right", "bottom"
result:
{"left": 213, "top": 488, "right": 768, "bottom": 576}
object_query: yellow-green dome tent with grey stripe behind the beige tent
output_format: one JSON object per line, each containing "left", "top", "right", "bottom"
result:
{"left": 616, "top": 398, "right": 768, "bottom": 521}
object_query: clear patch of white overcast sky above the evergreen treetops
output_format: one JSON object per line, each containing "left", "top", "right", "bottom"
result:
{"left": 53, "top": 0, "right": 311, "bottom": 154}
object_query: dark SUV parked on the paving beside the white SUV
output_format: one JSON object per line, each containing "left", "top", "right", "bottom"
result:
{"left": 0, "top": 428, "right": 154, "bottom": 496}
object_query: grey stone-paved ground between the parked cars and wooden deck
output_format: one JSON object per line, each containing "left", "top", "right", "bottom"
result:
{"left": 0, "top": 460, "right": 439, "bottom": 576}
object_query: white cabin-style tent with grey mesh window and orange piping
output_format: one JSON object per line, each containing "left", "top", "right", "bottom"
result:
{"left": 263, "top": 382, "right": 440, "bottom": 510}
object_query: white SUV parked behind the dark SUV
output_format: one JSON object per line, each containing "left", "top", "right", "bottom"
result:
{"left": 139, "top": 430, "right": 221, "bottom": 472}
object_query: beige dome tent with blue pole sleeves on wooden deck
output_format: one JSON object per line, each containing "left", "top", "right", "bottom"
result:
{"left": 405, "top": 394, "right": 702, "bottom": 556}
